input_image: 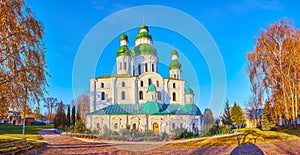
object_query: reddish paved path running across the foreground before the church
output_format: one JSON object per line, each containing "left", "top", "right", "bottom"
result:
{"left": 27, "top": 130, "right": 300, "bottom": 155}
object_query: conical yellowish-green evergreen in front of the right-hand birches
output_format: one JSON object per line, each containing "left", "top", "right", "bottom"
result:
{"left": 261, "top": 102, "right": 277, "bottom": 130}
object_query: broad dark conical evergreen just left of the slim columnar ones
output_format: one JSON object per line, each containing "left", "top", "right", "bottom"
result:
{"left": 54, "top": 101, "right": 67, "bottom": 129}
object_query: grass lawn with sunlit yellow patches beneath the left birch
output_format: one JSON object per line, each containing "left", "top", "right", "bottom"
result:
{"left": 0, "top": 124, "right": 53, "bottom": 148}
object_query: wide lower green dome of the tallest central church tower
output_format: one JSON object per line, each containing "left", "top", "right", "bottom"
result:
{"left": 131, "top": 44, "right": 157, "bottom": 56}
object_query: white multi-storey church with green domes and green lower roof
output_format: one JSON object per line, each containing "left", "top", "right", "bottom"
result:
{"left": 86, "top": 25, "right": 203, "bottom": 134}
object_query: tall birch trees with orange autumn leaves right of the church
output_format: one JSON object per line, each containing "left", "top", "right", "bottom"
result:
{"left": 247, "top": 19, "right": 300, "bottom": 127}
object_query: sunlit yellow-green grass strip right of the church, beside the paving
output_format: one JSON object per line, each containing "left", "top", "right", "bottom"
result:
{"left": 168, "top": 128, "right": 299, "bottom": 146}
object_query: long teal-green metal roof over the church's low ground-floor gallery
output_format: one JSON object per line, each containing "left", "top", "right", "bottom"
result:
{"left": 88, "top": 101, "right": 202, "bottom": 115}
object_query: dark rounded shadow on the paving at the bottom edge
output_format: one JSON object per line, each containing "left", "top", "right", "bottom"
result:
{"left": 230, "top": 144, "right": 264, "bottom": 155}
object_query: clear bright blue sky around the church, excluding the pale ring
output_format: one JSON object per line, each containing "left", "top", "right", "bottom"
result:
{"left": 26, "top": 0, "right": 300, "bottom": 115}
